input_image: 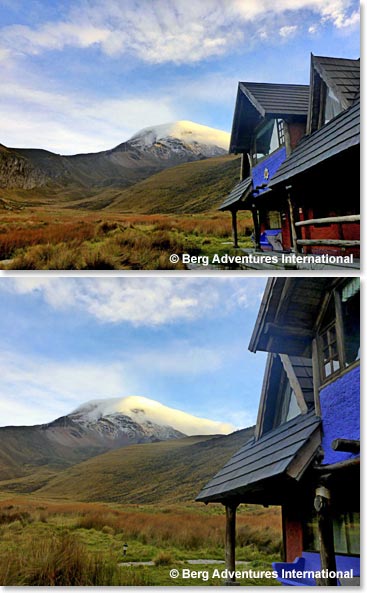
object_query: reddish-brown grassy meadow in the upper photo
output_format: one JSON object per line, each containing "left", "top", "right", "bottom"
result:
{"left": 0, "top": 208, "right": 252, "bottom": 270}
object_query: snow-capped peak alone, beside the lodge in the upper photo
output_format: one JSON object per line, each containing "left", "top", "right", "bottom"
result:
{"left": 128, "top": 120, "right": 230, "bottom": 158}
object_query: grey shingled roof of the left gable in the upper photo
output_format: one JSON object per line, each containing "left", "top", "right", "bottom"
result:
{"left": 239, "top": 82, "right": 309, "bottom": 117}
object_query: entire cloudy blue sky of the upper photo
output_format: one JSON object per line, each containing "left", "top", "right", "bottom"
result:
{"left": 0, "top": 0, "right": 359, "bottom": 154}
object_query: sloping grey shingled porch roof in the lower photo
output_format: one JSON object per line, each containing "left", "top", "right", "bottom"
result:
{"left": 196, "top": 411, "right": 321, "bottom": 502}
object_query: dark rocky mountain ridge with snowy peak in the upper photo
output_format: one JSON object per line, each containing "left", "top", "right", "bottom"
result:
{"left": 0, "top": 121, "right": 229, "bottom": 191}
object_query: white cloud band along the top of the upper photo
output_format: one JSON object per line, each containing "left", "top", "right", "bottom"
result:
{"left": 2, "top": 0, "right": 358, "bottom": 64}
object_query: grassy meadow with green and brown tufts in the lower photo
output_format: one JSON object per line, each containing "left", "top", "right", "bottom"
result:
{"left": 0, "top": 495, "right": 281, "bottom": 586}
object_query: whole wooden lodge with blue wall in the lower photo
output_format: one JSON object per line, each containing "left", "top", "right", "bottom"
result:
{"left": 197, "top": 277, "right": 360, "bottom": 585}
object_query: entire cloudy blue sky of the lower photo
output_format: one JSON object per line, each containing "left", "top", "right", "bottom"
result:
{"left": 0, "top": 277, "right": 266, "bottom": 427}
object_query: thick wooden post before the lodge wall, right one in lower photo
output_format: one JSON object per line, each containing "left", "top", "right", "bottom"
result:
{"left": 315, "top": 485, "right": 338, "bottom": 587}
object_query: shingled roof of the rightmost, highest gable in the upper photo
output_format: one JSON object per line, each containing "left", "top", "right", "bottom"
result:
{"left": 312, "top": 56, "right": 360, "bottom": 109}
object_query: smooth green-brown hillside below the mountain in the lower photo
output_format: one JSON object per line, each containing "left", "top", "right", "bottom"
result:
{"left": 0, "top": 428, "right": 253, "bottom": 504}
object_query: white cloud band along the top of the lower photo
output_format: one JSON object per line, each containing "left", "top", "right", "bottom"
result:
{"left": 2, "top": 277, "right": 264, "bottom": 326}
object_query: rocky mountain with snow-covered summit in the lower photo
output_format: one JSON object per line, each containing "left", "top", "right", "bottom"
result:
{"left": 0, "top": 397, "right": 231, "bottom": 480}
